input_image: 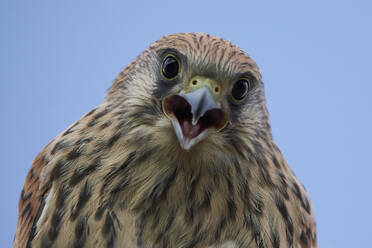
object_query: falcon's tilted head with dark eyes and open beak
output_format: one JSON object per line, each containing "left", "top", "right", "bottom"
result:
{"left": 106, "top": 33, "right": 270, "bottom": 155}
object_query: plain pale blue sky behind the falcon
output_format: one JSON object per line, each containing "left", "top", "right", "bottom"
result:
{"left": 0, "top": 0, "right": 372, "bottom": 248}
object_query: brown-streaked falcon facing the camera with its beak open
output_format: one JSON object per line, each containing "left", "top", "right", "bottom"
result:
{"left": 13, "top": 33, "right": 317, "bottom": 248}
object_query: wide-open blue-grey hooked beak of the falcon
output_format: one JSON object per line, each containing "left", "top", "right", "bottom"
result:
{"left": 162, "top": 78, "right": 228, "bottom": 150}
